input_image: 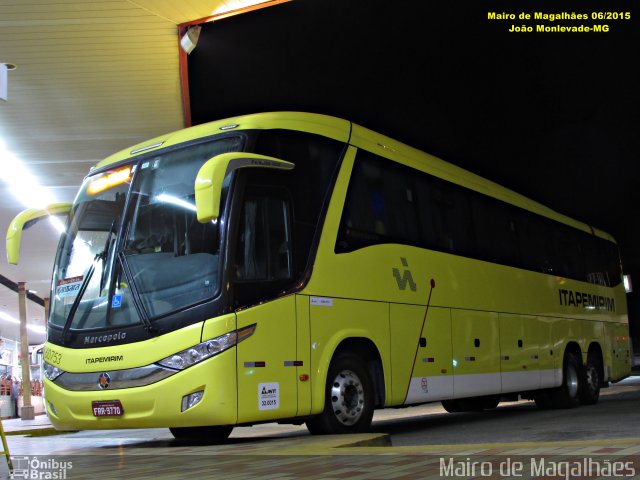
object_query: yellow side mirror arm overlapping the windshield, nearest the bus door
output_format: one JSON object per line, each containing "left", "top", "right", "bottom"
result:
{"left": 195, "top": 152, "right": 295, "bottom": 223}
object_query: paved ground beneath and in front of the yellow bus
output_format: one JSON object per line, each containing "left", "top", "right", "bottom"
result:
{"left": 0, "top": 377, "right": 640, "bottom": 480}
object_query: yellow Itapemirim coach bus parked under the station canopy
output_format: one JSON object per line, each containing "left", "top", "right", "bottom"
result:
{"left": 7, "top": 112, "right": 630, "bottom": 440}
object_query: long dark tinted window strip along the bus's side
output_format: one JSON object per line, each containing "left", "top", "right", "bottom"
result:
{"left": 335, "top": 150, "right": 622, "bottom": 287}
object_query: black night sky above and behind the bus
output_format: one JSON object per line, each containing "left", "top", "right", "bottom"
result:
{"left": 188, "top": 0, "right": 640, "bottom": 344}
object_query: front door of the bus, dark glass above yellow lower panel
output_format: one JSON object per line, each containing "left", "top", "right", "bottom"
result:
{"left": 233, "top": 188, "right": 299, "bottom": 423}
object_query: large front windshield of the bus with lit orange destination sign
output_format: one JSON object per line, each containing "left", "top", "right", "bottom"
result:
{"left": 50, "top": 137, "right": 242, "bottom": 331}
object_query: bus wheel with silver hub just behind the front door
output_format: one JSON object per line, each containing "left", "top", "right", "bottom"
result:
{"left": 306, "top": 353, "right": 373, "bottom": 435}
